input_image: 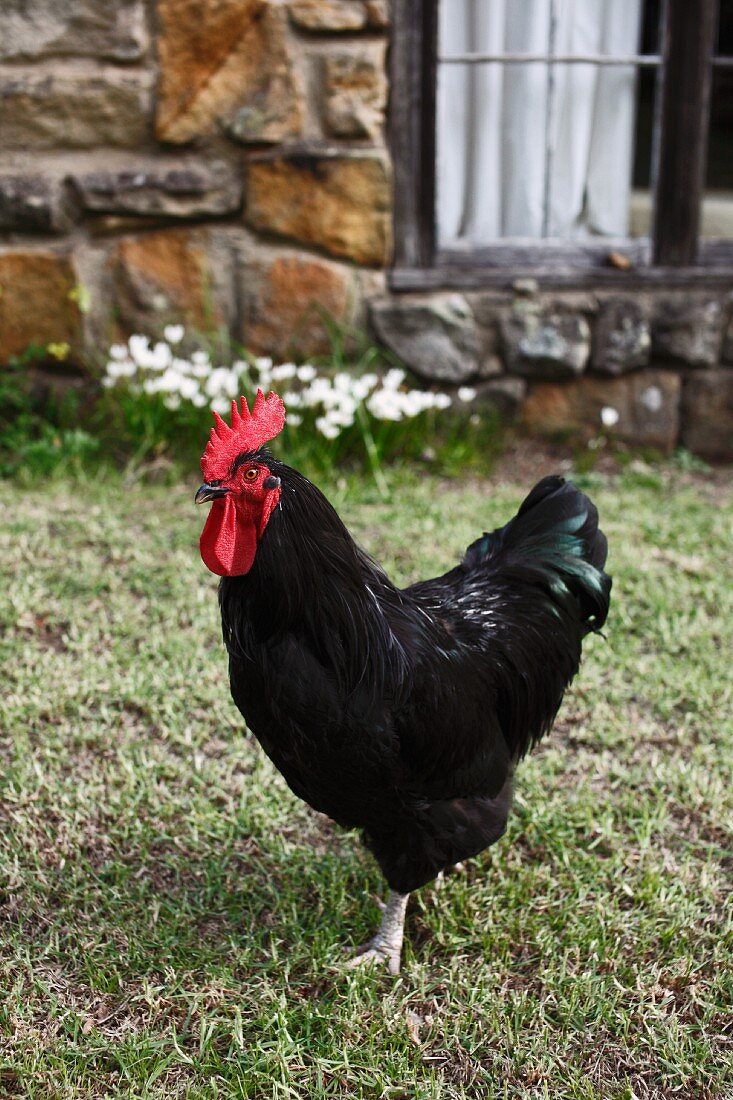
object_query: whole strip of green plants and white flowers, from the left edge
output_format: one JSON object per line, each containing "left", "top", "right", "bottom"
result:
{"left": 0, "top": 318, "right": 502, "bottom": 493}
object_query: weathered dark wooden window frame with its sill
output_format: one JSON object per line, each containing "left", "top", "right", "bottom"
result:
{"left": 390, "top": 0, "right": 733, "bottom": 290}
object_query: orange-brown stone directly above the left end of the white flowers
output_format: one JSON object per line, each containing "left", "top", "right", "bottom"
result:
{"left": 110, "top": 229, "right": 228, "bottom": 337}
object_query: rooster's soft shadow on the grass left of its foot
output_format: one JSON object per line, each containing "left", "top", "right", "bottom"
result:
{"left": 0, "top": 805, "right": 394, "bottom": 993}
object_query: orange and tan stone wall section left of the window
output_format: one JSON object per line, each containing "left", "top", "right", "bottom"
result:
{"left": 0, "top": 0, "right": 391, "bottom": 361}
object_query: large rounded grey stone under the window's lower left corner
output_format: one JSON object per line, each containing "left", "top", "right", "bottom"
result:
{"left": 371, "top": 294, "right": 481, "bottom": 383}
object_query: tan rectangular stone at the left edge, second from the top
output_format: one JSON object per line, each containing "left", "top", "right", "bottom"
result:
{"left": 0, "top": 69, "right": 152, "bottom": 150}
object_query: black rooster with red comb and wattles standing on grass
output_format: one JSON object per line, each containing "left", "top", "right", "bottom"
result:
{"left": 196, "top": 393, "right": 611, "bottom": 974}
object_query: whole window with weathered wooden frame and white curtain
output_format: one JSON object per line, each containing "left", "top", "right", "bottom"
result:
{"left": 391, "top": 0, "right": 733, "bottom": 288}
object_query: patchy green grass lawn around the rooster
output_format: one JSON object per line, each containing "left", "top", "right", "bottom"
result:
{"left": 0, "top": 459, "right": 733, "bottom": 1100}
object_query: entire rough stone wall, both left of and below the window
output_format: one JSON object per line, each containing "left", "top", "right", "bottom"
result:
{"left": 0, "top": 0, "right": 733, "bottom": 457}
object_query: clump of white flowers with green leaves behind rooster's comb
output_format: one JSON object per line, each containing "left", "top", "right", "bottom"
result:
{"left": 99, "top": 326, "right": 499, "bottom": 488}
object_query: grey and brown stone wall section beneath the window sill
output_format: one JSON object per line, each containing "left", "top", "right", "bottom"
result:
{"left": 370, "top": 288, "right": 733, "bottom": 459}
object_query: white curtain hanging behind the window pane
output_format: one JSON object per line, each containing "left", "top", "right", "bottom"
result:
{"left": 437, "top": 0, "right": 642, "bottom": 248}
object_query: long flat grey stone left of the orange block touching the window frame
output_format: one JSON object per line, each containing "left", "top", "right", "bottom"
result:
{"left": 68, "top": 161, "right": 242, "bottom": 218}
